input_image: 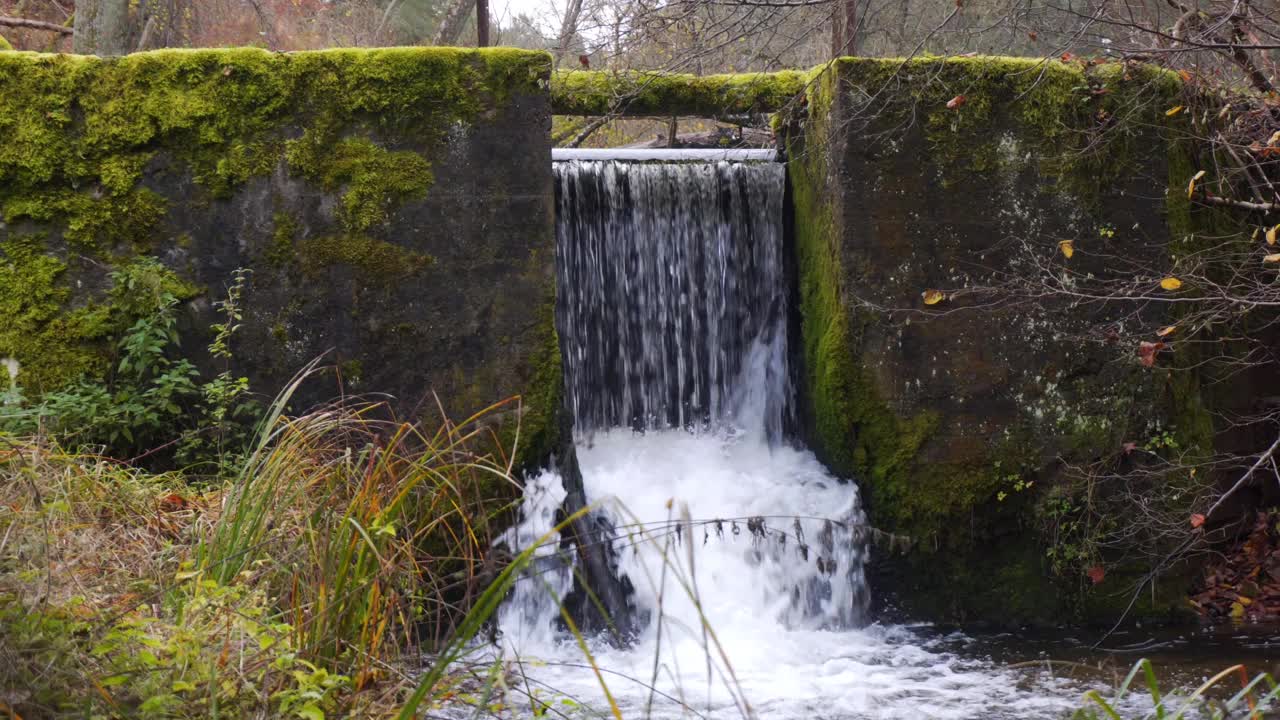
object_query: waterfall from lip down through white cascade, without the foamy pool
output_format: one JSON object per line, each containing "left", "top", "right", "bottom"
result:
{"left": 503, "top": 152, "right": 868, "bottom": 650}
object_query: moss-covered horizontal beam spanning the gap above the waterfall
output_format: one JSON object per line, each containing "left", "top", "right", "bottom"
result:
{"left": 552, "top": 70, "right": 810, "bottom": 117}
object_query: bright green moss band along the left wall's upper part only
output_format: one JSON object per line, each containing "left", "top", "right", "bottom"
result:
{"left": 0, "top": 49, "right": 550, "bottom": 249}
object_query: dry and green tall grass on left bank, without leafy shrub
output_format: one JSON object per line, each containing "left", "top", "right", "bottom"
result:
{"left": 0, "top": 366, "right": 540, "bottom": 717}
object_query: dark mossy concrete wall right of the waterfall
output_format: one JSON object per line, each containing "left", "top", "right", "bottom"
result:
{"left": 782, "top": 58, "right": 1208, "bottom": 623}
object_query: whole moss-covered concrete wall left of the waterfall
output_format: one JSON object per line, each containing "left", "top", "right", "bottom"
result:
{"left": 0, "top": 49, "right": 559, "bottom": 458}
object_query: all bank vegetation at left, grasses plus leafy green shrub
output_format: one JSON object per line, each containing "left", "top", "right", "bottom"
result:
{"left": 0, "top": 259, "right": 535, "bottom": 719}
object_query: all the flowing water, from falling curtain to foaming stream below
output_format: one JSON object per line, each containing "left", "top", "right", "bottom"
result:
{"left": 486, "top": 161, "right": 1079, "bottom": 719}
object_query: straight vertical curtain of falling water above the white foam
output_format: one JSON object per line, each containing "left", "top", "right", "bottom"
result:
{"left": 554, "top": 160, "right": 792, "bottom": 439}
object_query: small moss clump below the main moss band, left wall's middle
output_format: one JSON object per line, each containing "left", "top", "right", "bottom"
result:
{"left": 285, "top": 134, "right": 434, "bottom": 233}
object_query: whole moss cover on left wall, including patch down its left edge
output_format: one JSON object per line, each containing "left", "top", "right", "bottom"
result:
{"left": 0, "top": 47, "right": 550, "bottom": 425}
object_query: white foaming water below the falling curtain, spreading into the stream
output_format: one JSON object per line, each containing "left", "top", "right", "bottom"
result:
{"left": 488, "top": 430, "right": 1082, "bottom": 720}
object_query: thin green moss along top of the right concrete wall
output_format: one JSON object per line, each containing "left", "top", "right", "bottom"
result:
{"left": 836, "top": 56, "right": 1181, "bottom": 192}
